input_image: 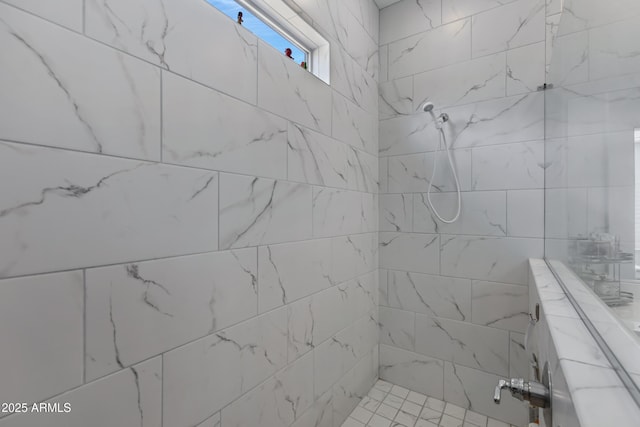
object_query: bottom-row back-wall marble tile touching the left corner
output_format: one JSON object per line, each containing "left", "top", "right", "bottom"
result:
{"left": 380, "top": 345, "right": 444, "bottom": 399}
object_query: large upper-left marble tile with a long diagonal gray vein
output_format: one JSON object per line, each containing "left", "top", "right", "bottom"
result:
{"left": 0, "top": 1, "right": 160, "bottom": 160}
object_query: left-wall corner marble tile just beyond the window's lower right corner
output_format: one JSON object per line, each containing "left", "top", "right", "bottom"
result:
{"left": 332, "top": 93, "right": 378, "bottom": 155}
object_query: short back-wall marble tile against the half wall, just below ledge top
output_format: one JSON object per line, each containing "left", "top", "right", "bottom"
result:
{"left": 471, "top": 280, "right": 529, "bottom": 333}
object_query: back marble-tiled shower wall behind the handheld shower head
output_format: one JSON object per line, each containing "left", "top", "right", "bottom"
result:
{"left": 379, "top": 0, "right": 550, "bottom": 425}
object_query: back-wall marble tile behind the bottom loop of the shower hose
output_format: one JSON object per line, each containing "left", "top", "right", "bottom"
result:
{"left": 413, "top": 191, "right": 507, "bottom": 236}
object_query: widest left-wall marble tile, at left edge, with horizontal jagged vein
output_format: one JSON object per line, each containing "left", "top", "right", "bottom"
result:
{"left": 0, "top": 143, "right": 218, "bottom": 277}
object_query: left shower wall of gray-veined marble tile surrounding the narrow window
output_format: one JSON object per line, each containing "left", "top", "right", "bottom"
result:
{"left": 0, "top": 0, "right": 378, "bottom": 427}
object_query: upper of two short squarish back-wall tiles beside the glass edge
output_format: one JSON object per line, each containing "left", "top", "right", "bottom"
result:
{"left": 507, "top": 42, "right": 545, "bottom": 95}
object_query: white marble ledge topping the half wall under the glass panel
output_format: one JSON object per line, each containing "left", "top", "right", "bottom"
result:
{"left": 529, "top": 259, "right": 640, "bottom": 427}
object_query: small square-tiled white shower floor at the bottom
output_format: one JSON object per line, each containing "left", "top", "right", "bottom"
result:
{"left": 342, "top": 380, "right": 516, "bottom": 427}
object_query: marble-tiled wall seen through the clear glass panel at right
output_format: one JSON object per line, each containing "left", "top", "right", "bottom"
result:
{"left": 545, "top": 0, "right": 640, "bottom": 268}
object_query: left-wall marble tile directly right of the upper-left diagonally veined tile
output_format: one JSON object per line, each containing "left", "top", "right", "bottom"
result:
{"left": 162, "top": 72, "right": 287, "bottom": 178}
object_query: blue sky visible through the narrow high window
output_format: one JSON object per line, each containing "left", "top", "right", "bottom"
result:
{"left": 207, "top": 0, "right": 305, "bottom": 64}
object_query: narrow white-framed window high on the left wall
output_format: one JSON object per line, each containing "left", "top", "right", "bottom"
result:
{"left": 206, "top": 0, "right": 329, "bottom": 83}
